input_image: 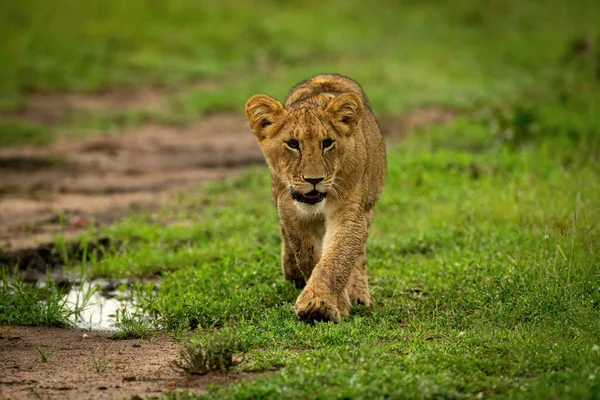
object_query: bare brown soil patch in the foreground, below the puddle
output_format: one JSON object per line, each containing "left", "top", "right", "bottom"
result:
{"left": 0, "top": 326, "right": 257, "bottom": 399}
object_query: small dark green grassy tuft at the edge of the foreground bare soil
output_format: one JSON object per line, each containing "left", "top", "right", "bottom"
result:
{"left": 171, "top": 330, "right": 238, "bottom": 375}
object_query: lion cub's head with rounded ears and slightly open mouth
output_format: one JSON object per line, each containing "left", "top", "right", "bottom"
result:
{"left": 246, "top": 93, "right": 364, "bottom": 204}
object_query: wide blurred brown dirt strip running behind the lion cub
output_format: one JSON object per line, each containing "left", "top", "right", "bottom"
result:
{"left": 0, "top": 108, "right": 453, "bottom": 252}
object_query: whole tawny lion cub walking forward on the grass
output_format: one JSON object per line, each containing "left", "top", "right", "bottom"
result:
{"left": 246, "top": 75, "right": 386, "bottom": 322}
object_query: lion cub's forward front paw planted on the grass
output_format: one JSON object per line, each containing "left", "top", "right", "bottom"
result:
{"left": 294, "top": 287, "right": 349, "bottom": 323}
